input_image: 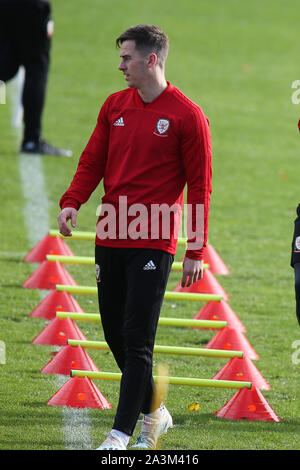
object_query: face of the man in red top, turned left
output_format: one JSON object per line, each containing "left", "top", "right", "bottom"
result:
{"left": 118, "top": 40, "right": 148, "bottom": 88}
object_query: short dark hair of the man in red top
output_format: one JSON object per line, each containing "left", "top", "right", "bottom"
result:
{"left": 116, "top": 24, "right": 169, "bottom": 61}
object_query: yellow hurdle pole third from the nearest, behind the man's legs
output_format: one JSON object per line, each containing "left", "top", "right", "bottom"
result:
{"left": 56, "top": 311, "right": 228, "bottom": 329}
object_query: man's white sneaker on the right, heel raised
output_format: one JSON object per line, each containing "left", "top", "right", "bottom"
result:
{"left": 131, "top": 405, "right": 173, "bottom": 449}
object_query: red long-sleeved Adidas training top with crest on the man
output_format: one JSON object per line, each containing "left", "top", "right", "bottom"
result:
{"left": 60, "top": 82, "right": 212, "bottom": 259}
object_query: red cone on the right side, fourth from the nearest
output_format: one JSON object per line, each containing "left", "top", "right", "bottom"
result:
{"left": 193, "top": 300, "right": 247, "bottom": 333}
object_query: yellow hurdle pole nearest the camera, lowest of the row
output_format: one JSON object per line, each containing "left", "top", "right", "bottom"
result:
{"left": 70, "top": 369, "right": 252, "bottom": 389}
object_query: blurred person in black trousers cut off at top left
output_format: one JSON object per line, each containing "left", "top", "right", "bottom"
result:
{"left": 0, "top": 0, "right": 72, "bottom": 157}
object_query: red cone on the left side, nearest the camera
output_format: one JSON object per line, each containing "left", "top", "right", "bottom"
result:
{"left": 47, "top": 376, "right": 111, "bottom": 410}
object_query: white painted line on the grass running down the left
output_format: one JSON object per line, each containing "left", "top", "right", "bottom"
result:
{"left": 9, "top": 68, "right": 92, "bottom": 450}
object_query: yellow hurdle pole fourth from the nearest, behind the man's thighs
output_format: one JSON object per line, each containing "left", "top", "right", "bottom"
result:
{"left": 56, "top": 284, "right": 223, "bottom": 302}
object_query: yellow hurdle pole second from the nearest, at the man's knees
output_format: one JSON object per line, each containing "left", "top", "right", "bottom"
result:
{"left": 67, "top": 339, "right": 244, "bottom": 359}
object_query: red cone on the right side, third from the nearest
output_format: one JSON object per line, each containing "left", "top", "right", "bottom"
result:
{"left": 205, "top": 326, "right": 259, "bottom": 360}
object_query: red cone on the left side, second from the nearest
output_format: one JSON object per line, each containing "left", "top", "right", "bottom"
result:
{"left": 41, "top": 344, "right": 99, "bottom": 375}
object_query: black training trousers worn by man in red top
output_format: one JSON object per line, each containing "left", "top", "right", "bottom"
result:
{"left": 95, "top": 246, "right": 174, "bottom": 436}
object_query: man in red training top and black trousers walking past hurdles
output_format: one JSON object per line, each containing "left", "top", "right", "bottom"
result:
{"left": 58, "top": 25, "right": 211, "bottom": 450}
